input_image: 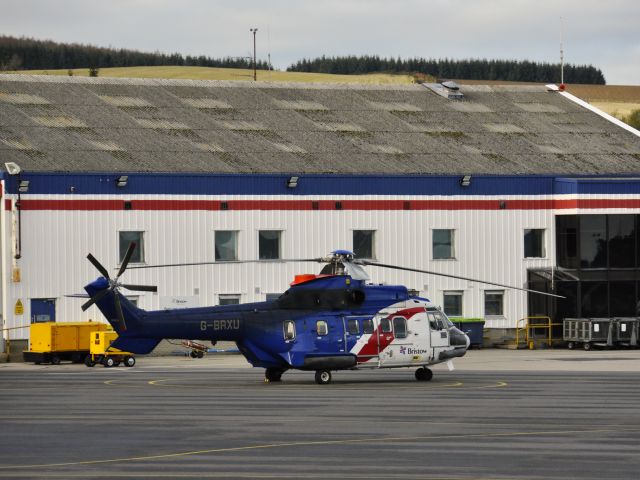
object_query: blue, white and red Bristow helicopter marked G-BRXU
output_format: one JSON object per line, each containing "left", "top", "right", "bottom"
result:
{"left": 82, "top": 242, "right": 558, "bottom": 385}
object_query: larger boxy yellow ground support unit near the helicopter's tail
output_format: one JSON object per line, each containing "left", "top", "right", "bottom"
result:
{"left": 22, "top": 322, "right": 111, "bottom": 365}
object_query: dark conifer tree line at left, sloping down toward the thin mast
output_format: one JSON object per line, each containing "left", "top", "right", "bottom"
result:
{"left": 0, "top": 35, "right": 269, "bottom": 71}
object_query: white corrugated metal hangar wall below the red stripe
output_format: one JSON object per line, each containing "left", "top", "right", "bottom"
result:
{"left": 5, "top": 191, "right": 555, "bottom": 338}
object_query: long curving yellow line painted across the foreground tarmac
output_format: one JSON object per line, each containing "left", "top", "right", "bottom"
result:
{"left": 0, "top": 428, "right": 640, "bottom": 470}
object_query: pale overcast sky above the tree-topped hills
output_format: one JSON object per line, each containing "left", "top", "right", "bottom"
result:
{"left": 0, "top": 0, "right": 640, "bottom": 85}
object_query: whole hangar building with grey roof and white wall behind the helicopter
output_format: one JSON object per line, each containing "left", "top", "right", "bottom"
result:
{"left": 0, "top": 75, "right": 640, "bottom": 352}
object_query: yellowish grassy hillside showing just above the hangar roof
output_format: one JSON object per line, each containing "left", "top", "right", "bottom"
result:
{"left": 6, "top": 66, "right": 640, "bottom": 122}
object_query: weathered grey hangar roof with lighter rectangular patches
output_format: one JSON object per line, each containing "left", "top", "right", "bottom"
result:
{"left": 0, "top": 75, "right": 640, "bottom": 175}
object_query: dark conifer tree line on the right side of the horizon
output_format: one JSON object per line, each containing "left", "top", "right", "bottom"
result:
{"left": 287, "top": 55, "right": 605, "bottom": 85}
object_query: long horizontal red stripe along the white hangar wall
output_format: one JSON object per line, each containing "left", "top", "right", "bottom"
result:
{"left": 5, "top": 198, "right": 640, "bottom": 211}
